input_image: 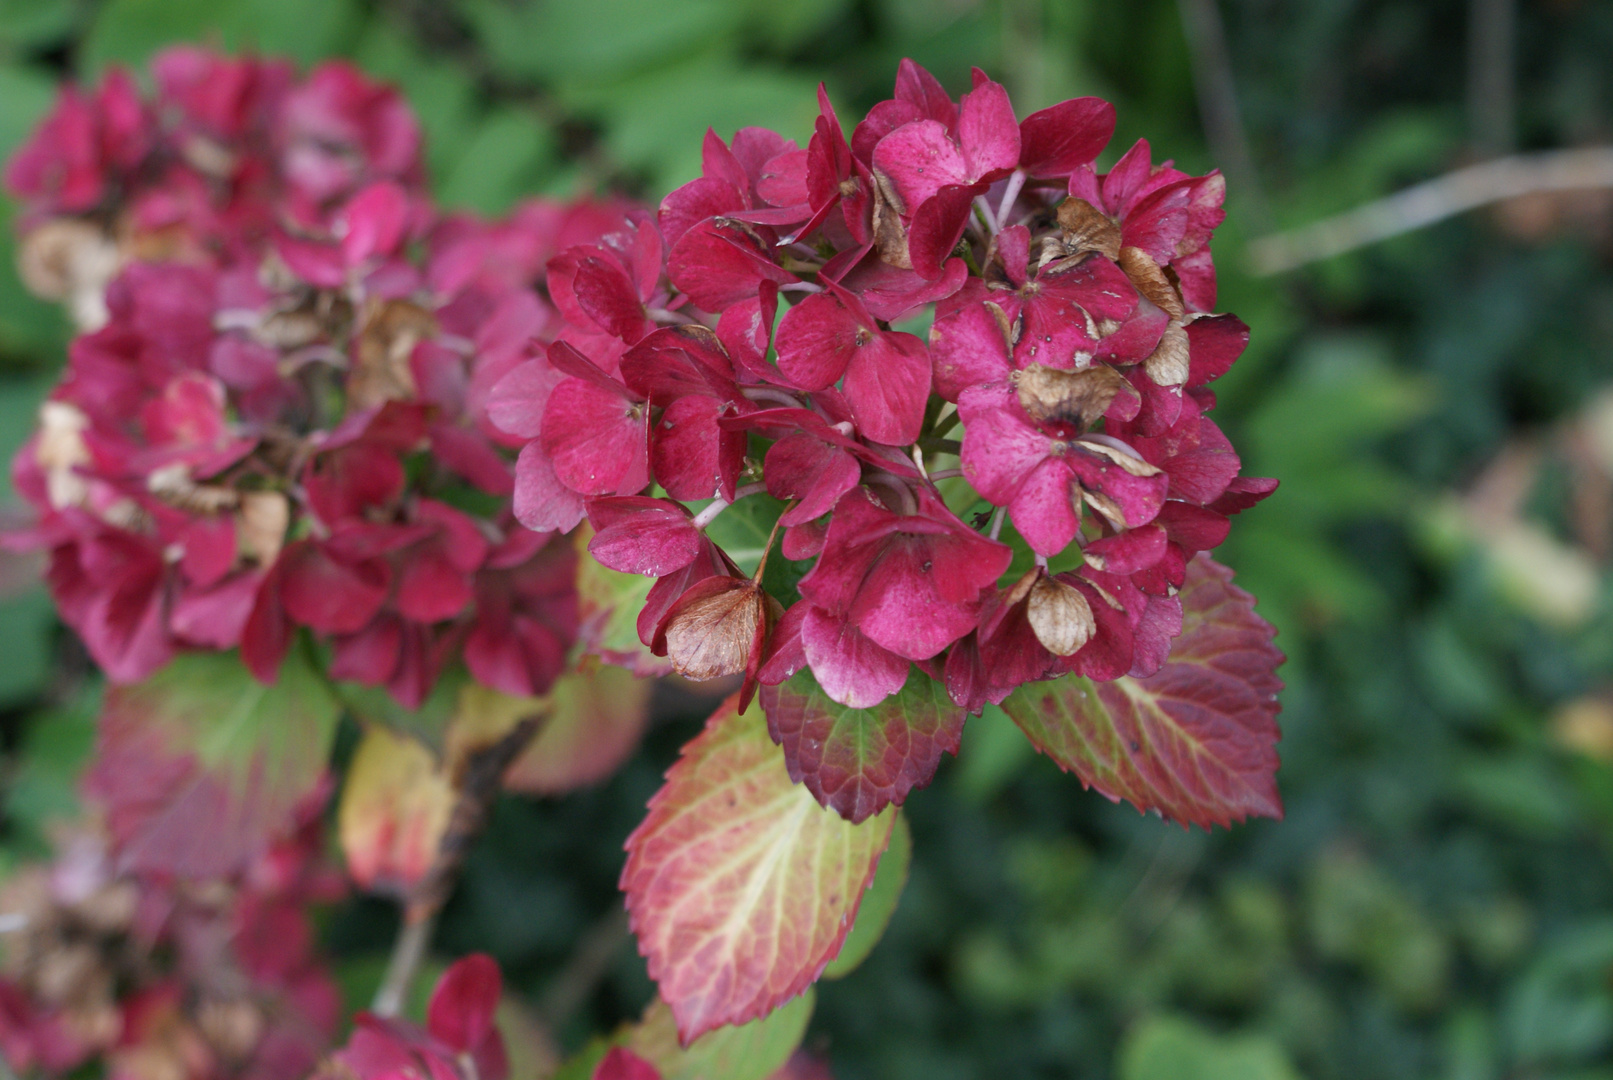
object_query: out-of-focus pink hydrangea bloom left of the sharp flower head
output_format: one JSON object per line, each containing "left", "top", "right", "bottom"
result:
{"left": 6, "top": 48, "right": 648, "bottom": 706}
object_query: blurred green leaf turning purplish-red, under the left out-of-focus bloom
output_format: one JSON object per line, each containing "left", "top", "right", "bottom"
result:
{"left": 84, "top": 653, "right": 337, "bottom": 877}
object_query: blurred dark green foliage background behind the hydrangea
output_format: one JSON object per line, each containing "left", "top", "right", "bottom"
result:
{"left": 0, "top": 0, "right": 1613, "bottom": 1080}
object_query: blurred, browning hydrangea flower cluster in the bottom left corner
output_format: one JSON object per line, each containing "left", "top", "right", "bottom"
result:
{"left": 0, "top": 822, "right": 344, "bottom": 1080}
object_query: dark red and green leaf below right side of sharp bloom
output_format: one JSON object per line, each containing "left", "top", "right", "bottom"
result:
{"left": 1003, "top": 555, "right": 1282, "bottom": 829}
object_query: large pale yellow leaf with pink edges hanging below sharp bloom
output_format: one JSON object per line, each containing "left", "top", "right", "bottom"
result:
{"left": 621, "top": 698, "right": 895, "bottom": 1045}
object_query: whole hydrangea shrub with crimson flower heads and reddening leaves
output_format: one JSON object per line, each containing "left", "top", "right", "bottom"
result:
{"left": 5, "top": 48, "right": 1281, "bottom": 1080}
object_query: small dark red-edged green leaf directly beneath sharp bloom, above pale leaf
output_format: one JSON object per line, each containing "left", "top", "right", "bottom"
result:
{"left": 761, "top": 669, "right": 965, "bottom": 822}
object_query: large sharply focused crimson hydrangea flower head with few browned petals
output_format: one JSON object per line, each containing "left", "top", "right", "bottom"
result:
{"left": 489, "top": 61, "right": 1276, "bottom": 711}
